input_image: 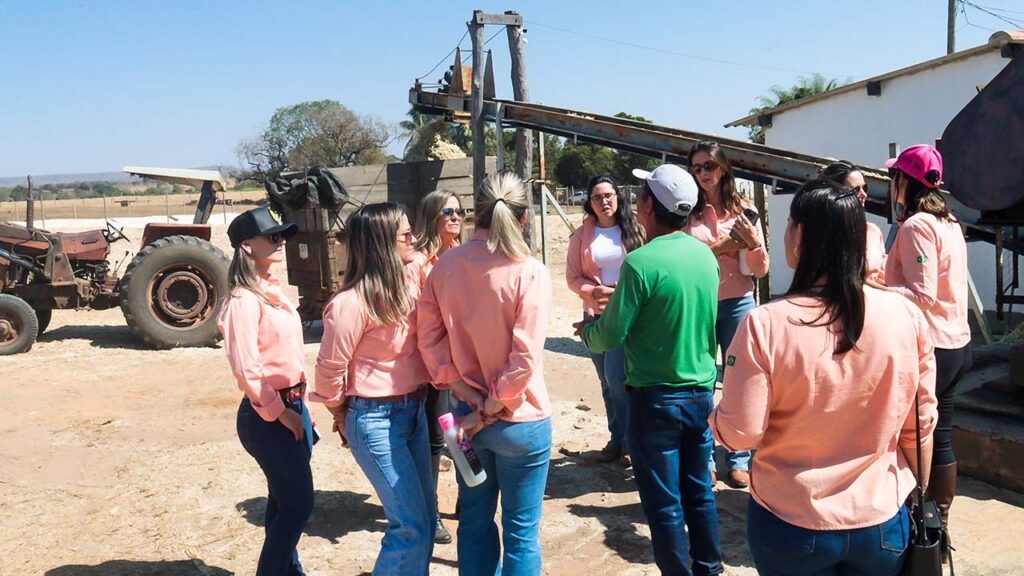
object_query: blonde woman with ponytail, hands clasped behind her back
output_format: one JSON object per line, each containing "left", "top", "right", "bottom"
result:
{"left": 418, "top": 173, "right": 551, "bottom": 576}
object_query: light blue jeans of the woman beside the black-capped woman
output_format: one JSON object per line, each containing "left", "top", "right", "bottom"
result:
{"left": 345, "top": 397, "right": 437, "bottom": 576}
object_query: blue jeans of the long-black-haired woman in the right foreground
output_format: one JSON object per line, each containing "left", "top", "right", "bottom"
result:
{"left": 746, "top": 498, "right": 910, "bottom": 576}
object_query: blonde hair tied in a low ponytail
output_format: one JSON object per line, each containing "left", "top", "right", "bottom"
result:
{"left": 476, "top": 172, "right": 530, "bottom": 260}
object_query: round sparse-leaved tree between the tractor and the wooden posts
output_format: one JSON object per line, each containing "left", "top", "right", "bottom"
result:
{"left": 239, "top": 100, "right": 391, "bottom": 179}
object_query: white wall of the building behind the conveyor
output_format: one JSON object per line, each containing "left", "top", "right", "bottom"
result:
{"left": 765, "top": 49, "right": 1010, "bottom": 310}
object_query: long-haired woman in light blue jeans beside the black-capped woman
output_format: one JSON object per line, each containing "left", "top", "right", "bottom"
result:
{"left": 310, "top": 202, "right": 436, "bottom": 576}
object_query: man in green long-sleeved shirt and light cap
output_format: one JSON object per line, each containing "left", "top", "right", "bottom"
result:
{"left": 577, "top": 164, "right": 724, "bottom": 575}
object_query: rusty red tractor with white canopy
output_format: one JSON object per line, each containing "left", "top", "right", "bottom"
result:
{"left": 0, "top": 168, "right": 228, "bottom": 356}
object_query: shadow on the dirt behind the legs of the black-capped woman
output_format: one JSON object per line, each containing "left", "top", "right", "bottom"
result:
{"left": 234, "top": 490, "right": 387, "bottom": 544}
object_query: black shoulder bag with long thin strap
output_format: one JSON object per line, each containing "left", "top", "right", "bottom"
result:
{"left": 902, "top": 387, "right": 954, "bottom": 576}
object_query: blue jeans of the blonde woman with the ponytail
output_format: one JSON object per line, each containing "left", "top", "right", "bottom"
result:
{"left": 453, "top": 401, "right": 551, "bottom": 576}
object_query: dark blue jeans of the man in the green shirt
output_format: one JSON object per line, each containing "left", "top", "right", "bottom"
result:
{"left": 629, "top": 386, "right": 725, "bottom": 576}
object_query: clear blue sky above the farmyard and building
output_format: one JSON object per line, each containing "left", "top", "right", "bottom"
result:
{"left": 0, "top": 0, "right": 1011, "bottom": 176}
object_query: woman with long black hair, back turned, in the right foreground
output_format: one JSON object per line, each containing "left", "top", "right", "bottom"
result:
{"left": 709, "top": 180, "right": 937, "bottom": 576}
